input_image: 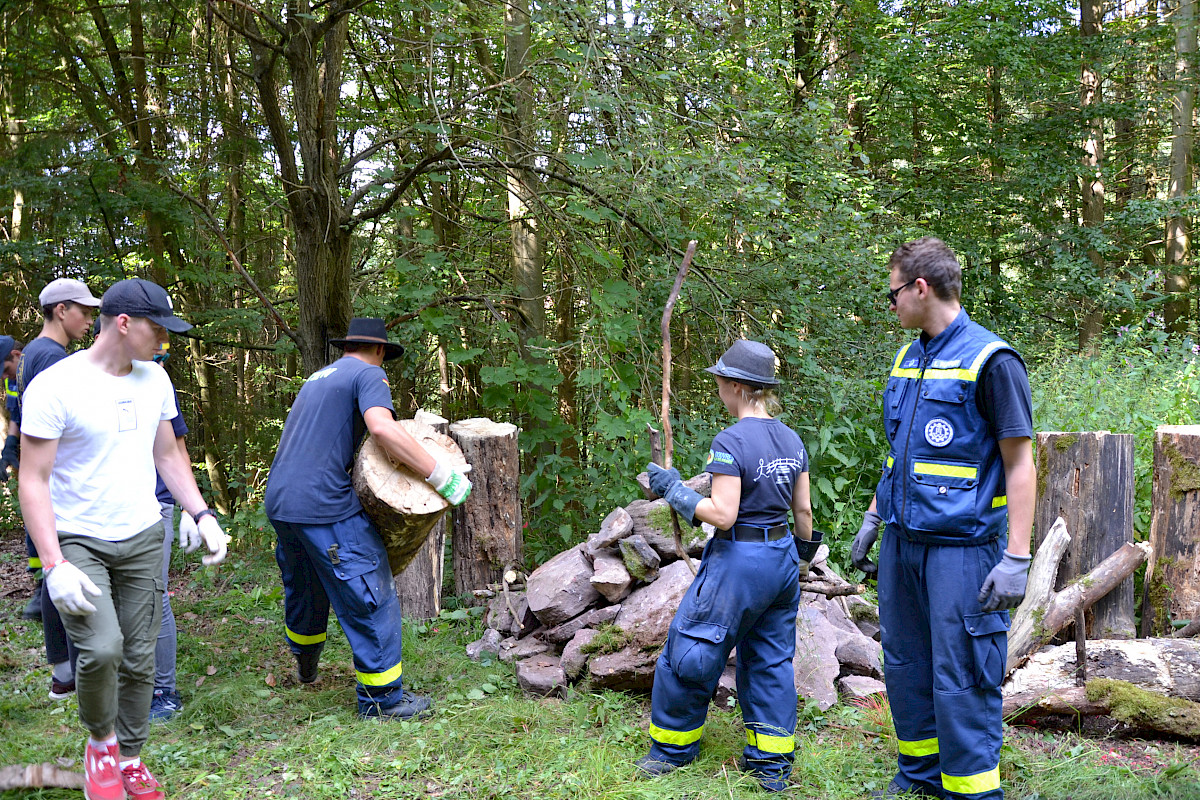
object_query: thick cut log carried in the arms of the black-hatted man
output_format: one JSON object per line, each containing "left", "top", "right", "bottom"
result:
{"left": 353, "top": 420, "right": 467, "bottom": 575}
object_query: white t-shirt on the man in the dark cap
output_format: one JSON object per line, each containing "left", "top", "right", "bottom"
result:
{"left": 20, "top": 350, "right": 179, "bottom": 542}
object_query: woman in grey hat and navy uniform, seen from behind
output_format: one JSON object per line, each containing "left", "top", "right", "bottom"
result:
{"left": 637, "top": 339, "right": 820, "bottom": 792}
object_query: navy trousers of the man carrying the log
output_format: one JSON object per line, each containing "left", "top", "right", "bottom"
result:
{"left": 271, "top": 511, "right": 402, "bottom": 712}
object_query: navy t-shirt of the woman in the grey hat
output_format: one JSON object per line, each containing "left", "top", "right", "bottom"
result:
{"left": 704, "top": 416, "right": 809, "bottom": 528}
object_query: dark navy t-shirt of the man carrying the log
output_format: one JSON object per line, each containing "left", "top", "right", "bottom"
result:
{"left": 264, "top": 356, "right": 392, "bottom": 524}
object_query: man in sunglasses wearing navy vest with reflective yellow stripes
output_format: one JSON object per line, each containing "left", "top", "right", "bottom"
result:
{"left": 851, "top": 236, "right": 1036, "bottom": 800}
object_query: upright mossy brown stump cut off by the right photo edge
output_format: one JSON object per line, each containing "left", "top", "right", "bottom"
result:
{"left": 1141, "top": 425, "right": 1200, "bottom": 636}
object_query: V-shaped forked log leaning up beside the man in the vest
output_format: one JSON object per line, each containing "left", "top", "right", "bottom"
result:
{"left": 1006, "top": 517, "right": 1153, "bottom": 674}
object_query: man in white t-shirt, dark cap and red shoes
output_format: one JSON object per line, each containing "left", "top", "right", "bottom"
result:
{"left": 20, "top": 278, "right": 226, "bottom": 800}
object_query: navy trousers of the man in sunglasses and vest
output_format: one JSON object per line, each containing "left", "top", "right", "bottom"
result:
{"left": 878, "top": 529, "right": 1009, "bottom": 800}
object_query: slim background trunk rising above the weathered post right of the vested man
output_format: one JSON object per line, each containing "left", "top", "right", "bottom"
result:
{"left": 1079, "top": 0, "right": 1104, "bottom": 349}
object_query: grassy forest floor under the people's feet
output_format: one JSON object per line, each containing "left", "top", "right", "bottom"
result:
{"left": 0, "top": 520, "right": 1200, "bottom": 800}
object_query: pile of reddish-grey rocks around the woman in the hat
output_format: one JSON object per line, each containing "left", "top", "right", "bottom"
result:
{"left": 467, "top": 474, "right": 883, "bottom": 709}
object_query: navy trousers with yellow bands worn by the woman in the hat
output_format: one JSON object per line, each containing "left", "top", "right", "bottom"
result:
{"left": 650, "top": 536, "right": 800, "bottom": 789}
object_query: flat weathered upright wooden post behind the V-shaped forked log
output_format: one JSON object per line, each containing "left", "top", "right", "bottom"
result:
{"left": 1033, "top": 431, "right": 1135, "bottom": 639}
